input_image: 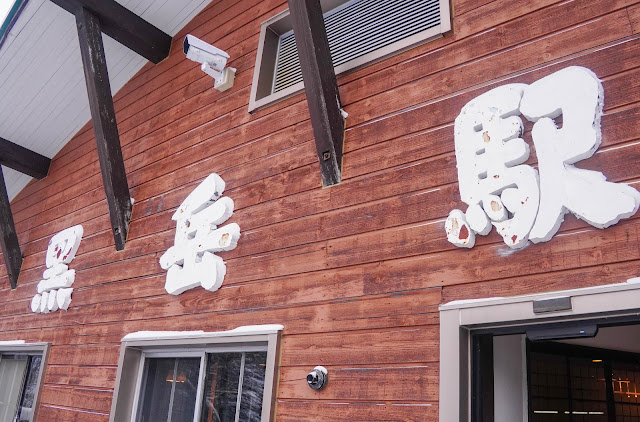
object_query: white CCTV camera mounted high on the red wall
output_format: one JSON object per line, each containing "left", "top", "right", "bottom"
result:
{"left": 183, "top": 35, "right": 236, "bottom": 91}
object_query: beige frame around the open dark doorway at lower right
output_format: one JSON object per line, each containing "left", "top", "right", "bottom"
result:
{"left": 439, "top": 279, "right": 640, "bottom": 422}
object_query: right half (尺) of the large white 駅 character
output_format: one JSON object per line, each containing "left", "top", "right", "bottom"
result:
{"left": 520, "top": 67, "right": 640, "bottom": 243}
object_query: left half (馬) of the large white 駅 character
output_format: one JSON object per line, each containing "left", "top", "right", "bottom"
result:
{"left": 447, "top": 84, "right": 539, "bottom": 248}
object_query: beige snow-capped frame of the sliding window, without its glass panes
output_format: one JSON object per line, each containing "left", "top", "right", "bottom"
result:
{"left": 109, "top": 325, "right": 283, "bottom": 422}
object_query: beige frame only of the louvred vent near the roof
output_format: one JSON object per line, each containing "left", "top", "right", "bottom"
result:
{"left": 249, "top": 0, "right": 452, "bottom": 113}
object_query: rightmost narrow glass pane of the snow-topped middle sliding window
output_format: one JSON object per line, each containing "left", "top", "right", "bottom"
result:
{"left": 239, "top": 352, "right": 267, "bottom": 422}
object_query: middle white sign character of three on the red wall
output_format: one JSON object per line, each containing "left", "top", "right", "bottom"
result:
{"left": 160, "top": 173, "right": 240, "bottom": 295}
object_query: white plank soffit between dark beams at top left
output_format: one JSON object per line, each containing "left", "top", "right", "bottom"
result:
{"left": 0, "top": 0, "right": 211, "bottom": 199}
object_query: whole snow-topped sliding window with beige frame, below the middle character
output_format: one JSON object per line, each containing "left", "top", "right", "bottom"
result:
{"left": 110, "top": 325, "right": 282, "bottom": 422}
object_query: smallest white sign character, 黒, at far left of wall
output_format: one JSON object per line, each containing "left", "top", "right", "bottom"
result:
{"left": 31, "top": 225, "right": 83, "bottom": 314}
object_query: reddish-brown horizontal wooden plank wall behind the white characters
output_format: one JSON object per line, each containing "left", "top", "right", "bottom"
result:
{"left": 0, "top": 0, "right": 640, "bottom": 422}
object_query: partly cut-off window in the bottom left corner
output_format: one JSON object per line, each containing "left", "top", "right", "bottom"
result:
{"left": 0, "top": 342, "right": 48, "bottom": 422}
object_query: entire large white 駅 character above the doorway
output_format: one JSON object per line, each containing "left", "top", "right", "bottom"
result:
{"left": 445, "top": 67, "right": 640, "bottom": 249}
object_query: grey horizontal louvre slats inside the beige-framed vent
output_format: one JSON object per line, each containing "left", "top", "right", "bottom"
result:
{"left": 272, "top": 0, "right": 440, "bottom": 93}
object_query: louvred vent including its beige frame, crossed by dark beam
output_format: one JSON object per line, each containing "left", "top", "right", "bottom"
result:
{"left": 249, "top": 0, "right": 451, "bottom": 112}
